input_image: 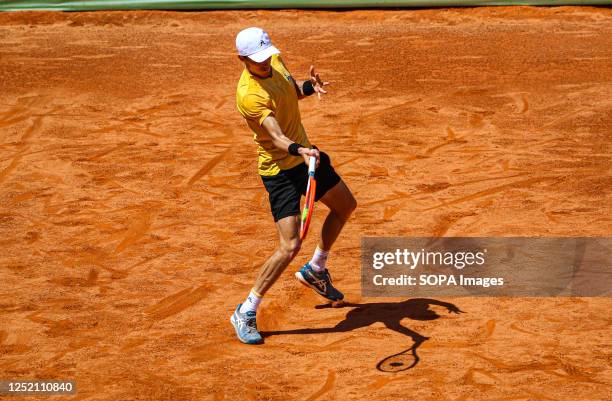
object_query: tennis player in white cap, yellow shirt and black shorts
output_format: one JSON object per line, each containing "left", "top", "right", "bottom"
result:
{"left": 231, "top": 28, "right": 357, "bottom": 344}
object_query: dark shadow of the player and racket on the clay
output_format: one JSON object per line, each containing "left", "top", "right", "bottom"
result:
{"left": 261, "top": 298, "right": 463, "bottom": 372}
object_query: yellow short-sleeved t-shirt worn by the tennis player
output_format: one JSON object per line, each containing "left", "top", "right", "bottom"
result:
{"left": 236, "top": 54, "right": 311, "bottom": 176}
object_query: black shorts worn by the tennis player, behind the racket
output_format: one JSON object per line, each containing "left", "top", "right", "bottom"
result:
{"left": 260, "top": 152, "right": 340, "bottom": 222}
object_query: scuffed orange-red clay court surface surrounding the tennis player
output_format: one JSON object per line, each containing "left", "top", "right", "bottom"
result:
{"left": 0, "top": 7, "right": 612, "bottom": 401}
